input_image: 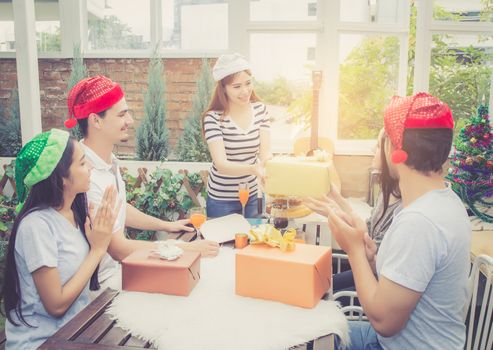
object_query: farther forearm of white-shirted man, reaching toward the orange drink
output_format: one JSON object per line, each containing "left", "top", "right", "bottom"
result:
{"left": 125, "top": 203, "right": 193, "bottom": 232}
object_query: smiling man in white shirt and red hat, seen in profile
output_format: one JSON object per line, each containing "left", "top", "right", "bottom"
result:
{"left": 65, "top": 76, "right": 219, "bottom": 296}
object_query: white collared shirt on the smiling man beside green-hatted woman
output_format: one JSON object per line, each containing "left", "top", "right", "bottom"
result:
{"left": 80, "top": 140, "right": 127, "bottom": 282}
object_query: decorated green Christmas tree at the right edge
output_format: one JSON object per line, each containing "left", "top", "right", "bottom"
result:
{"left": 447, "top": 105, "right": 493, "bottom": 223}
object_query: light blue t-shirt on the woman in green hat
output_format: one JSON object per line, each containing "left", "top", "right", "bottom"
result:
{"left": 5, "top": 208, "right": 89, "bottom": 349}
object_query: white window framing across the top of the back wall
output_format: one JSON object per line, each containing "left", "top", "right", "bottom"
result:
{"left": 9, "top": 0, "right": 493, "bottom": 154}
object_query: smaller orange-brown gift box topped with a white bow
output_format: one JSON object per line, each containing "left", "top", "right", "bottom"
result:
{"left": 122, "top": 249, "right": 200, "bottom": 296}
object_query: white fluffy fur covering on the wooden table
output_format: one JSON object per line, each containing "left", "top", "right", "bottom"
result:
{"left": 108, "top": 247, "right": 348, "bottom": 350}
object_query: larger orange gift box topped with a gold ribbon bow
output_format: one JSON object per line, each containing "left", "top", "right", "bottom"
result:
{"left": 236, "top": 243, "right": 332, "bottom": 308}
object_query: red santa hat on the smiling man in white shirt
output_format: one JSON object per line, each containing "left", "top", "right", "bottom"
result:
{"left": 65, "top": 75, "right": 124, "bottom": 129}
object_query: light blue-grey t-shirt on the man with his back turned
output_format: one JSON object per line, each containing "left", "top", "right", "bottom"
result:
{"left": 377, "top": 188, "right": 471, "bottom": 350}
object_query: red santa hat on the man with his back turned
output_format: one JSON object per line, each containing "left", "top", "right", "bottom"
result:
{"left": 384, "top": 92, "right": 454, "bottom": 164}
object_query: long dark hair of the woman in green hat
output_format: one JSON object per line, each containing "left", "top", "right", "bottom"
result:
{"left": 1, "top": 137, "right": 99, "bottom": 326}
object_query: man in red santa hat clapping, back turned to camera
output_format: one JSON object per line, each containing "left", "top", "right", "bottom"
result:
{"left": 328, "top": 93, "right": 471, "bottom": 350}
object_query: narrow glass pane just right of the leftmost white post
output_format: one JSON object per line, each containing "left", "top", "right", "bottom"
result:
{"left": 34, "top": 0, "right": 61, "bottom": 52}
